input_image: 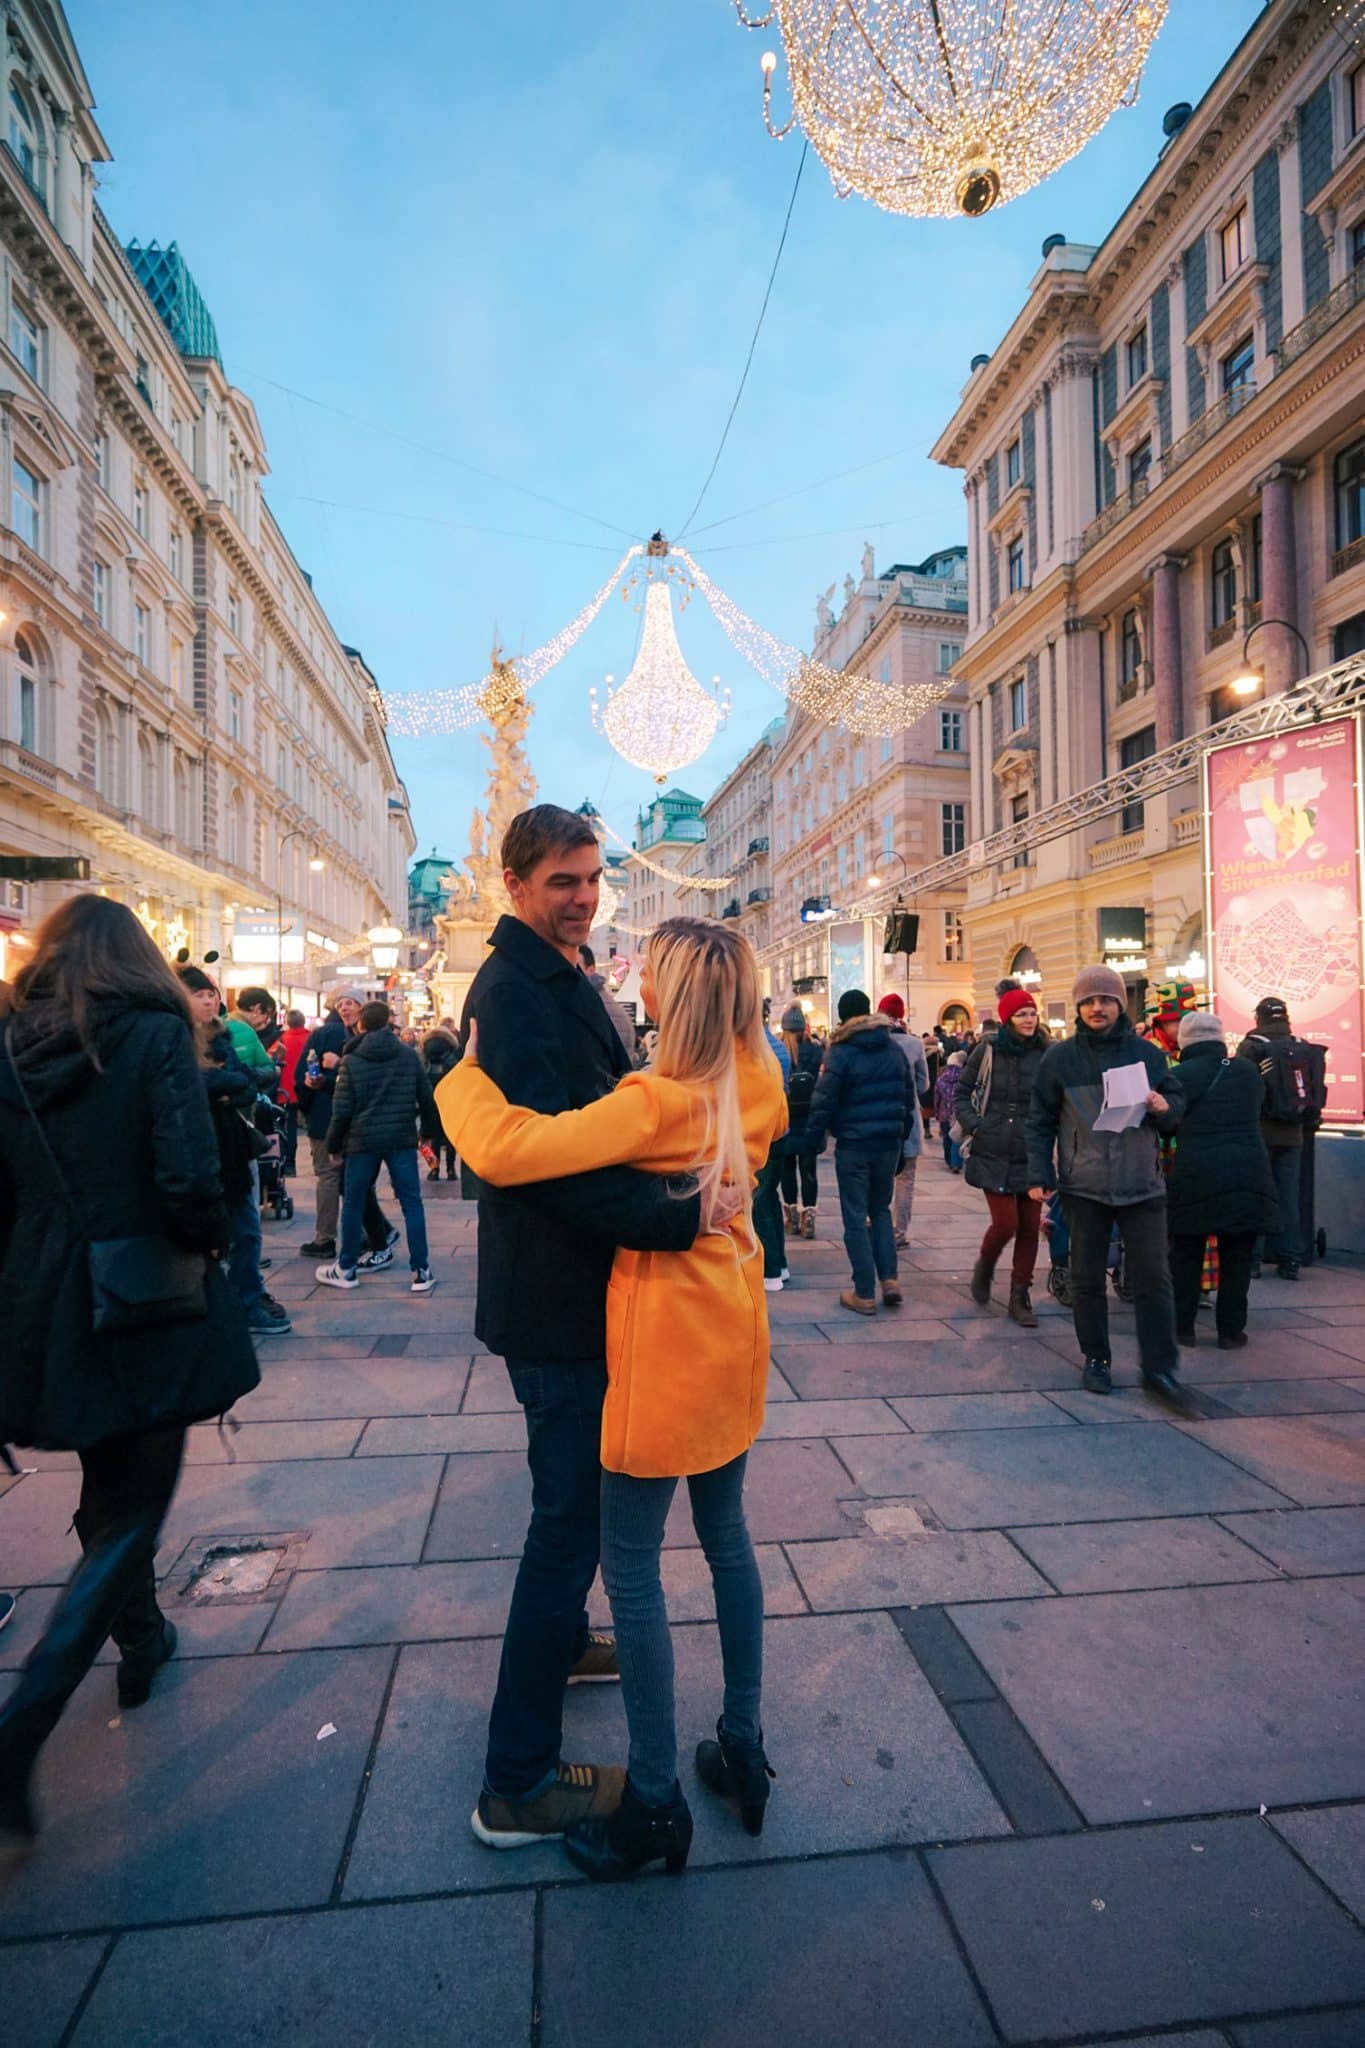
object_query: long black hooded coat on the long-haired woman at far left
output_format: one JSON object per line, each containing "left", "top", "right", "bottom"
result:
{"left": 0, "top": 999, "right": 260, "bottom": 1450}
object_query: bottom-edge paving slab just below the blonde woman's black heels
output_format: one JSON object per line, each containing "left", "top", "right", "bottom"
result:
{"left": 540, "top": 1851, "right": 995, "bottom": 2048}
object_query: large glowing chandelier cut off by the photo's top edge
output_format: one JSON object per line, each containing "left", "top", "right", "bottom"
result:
{"left": 735, "top": 0, "right": 1166, "bottom": 215}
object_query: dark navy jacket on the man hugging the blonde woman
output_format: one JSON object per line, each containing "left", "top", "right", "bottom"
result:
{"left": 460, "top": 918, "right": 702, "bottom": 1364}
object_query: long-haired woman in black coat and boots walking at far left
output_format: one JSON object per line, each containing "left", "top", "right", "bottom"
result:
{"left": 0, "top": 895, "right": 260, "bottom": 1843}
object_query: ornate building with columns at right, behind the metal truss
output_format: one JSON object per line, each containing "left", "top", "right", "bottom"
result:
{"left": 933, "top": 0, "right": 1365, "bottom": 1018}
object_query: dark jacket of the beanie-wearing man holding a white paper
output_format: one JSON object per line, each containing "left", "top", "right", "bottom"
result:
{"left": 1027, "top": 1014, "right": 1185, "bottom": 1208}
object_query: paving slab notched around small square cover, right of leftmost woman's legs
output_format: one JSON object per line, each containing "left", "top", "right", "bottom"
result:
{"left": 155, "top": 1458, "right": 444, "bottom": 1571}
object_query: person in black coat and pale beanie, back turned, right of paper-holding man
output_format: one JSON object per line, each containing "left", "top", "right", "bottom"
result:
{"left": 1166, "top": 1010, "right": 1275, "bottom": 1352}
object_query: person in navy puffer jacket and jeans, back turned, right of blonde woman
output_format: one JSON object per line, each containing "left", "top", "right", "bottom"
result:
{"left": 806, "top": 989, "right": 919, "bottom": 1315}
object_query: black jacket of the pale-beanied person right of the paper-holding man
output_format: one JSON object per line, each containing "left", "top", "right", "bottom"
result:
{"left": 1166, "top": 1038, "right": 1275, "bottom": 1237}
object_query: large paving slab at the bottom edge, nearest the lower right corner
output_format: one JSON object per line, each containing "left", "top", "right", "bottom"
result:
{"left": 929, "top": 1819, "right": 1365, "bottom": 2042}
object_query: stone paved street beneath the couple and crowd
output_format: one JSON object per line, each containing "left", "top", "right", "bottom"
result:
{"left": 0, "top": 1155, "right": 1365, "bottom": 2048}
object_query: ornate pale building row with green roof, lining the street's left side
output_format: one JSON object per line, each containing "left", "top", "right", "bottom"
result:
{"left": 0, "top": 0, "right": 413, "bottom": 997}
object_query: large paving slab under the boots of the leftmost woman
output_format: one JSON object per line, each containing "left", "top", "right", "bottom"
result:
{"left": 4, "top": 1651, "right": 393, "bottom": 1935}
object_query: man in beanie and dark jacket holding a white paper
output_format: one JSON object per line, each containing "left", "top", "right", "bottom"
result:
{"left": 1027, "top": 967, "right": 1185, "bottom": 1407}
